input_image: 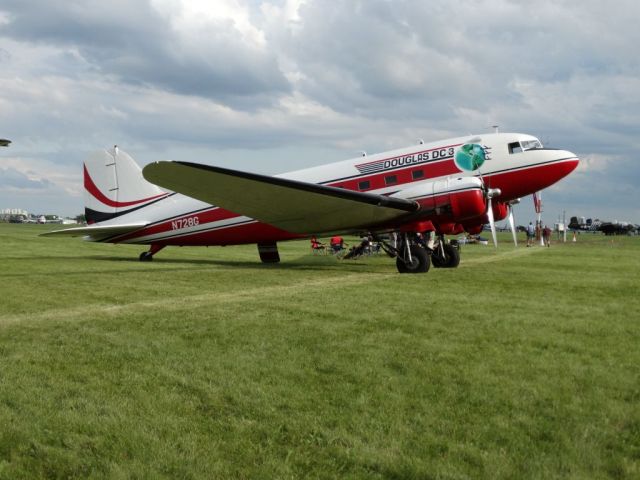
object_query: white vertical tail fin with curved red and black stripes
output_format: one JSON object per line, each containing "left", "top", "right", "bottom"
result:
{"left": 84, "top": 146, "right": 168, "bottom": 224}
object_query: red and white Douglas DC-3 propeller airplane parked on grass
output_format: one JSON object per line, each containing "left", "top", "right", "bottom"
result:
{"left": 44, "top": 133, "right": 579, "bottom": 273}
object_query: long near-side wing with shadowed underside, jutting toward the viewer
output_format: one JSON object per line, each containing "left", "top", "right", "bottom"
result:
{"left": 142, "top": 161, "right": 419, "bottom": 233}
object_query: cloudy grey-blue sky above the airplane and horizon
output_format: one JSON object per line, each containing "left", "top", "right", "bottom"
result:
{"left": 0, "top": 0, "right": 640, "bottom": 224}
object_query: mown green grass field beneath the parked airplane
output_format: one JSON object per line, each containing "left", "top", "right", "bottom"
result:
{"left": 0, "top": 224, "right": 640, "bottom": 479}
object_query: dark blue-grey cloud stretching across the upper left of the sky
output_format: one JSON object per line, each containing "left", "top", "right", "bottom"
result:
{"left": 0, "top": 0, "right": 290, "bottom": 104}
